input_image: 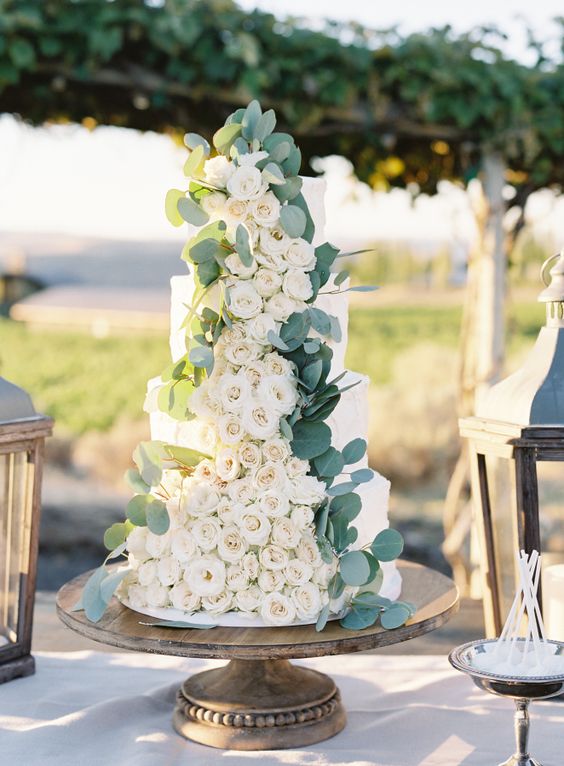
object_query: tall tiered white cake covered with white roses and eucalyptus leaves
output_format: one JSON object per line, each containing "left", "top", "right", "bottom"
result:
{"left": 78, "top": 101, "right": 413, "bottom": 630}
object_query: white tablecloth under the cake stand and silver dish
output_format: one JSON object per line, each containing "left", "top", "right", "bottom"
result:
{"left": 0, "top": 652, "right": 564, "bottom": 766}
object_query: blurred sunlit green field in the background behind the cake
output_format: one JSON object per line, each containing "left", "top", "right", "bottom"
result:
{"left": 0, "top": 303, "right": 543, "bottom": 435}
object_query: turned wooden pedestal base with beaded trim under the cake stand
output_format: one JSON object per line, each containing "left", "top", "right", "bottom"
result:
{"left": 173, "top": 660, "right": 346, "bottom": 750}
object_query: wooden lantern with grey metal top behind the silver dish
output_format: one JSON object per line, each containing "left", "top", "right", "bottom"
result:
{"left": 460, "top": 250, "right": 564, "bottom": 636}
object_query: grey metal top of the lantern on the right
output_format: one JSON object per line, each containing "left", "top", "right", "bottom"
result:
{"left": 476, "top": 250, "right": 564, "bottom": 427}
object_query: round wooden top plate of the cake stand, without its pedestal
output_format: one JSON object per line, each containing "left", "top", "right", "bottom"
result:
{"left": 57, "top": 562, "right": 459, "bottom": 660}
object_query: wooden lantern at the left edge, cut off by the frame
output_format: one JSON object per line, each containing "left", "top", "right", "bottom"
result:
{"left": 0, "top": 378, "right": 53, "bottom": 683}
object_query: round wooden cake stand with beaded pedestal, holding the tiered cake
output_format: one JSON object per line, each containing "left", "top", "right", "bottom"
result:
{"left": 57, "top": 562, "right": 458, "bottom": 750}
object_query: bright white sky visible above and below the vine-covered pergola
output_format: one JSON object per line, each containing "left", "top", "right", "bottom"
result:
{"left": 0, "top": 0, "right": 562, "bottom": 252}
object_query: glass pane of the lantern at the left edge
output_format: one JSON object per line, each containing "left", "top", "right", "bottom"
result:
{"left": 0, "top": 452, "right": 33, "bottom": 647}
